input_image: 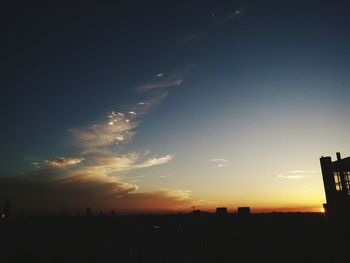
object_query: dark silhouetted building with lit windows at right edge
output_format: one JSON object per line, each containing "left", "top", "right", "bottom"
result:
{"left": 320, "top": 152, "right": 350, "bottom": 221}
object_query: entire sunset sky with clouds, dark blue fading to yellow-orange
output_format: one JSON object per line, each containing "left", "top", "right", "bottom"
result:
{"left": 0, "top": 0, "right": 350, "bottom": 213}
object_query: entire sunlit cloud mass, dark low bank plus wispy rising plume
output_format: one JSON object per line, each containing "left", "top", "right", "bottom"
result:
{"left": 0, "top": 93, "right": 183, "bottom": 212}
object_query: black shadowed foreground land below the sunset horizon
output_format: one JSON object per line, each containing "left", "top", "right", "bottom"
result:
{"left": 0, "top": 213, "right": 350, "bottom": 263}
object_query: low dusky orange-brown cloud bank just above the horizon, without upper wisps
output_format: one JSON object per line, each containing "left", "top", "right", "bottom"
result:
{"left": 0, "top": 169, "right": 193, "bottom": 213}
